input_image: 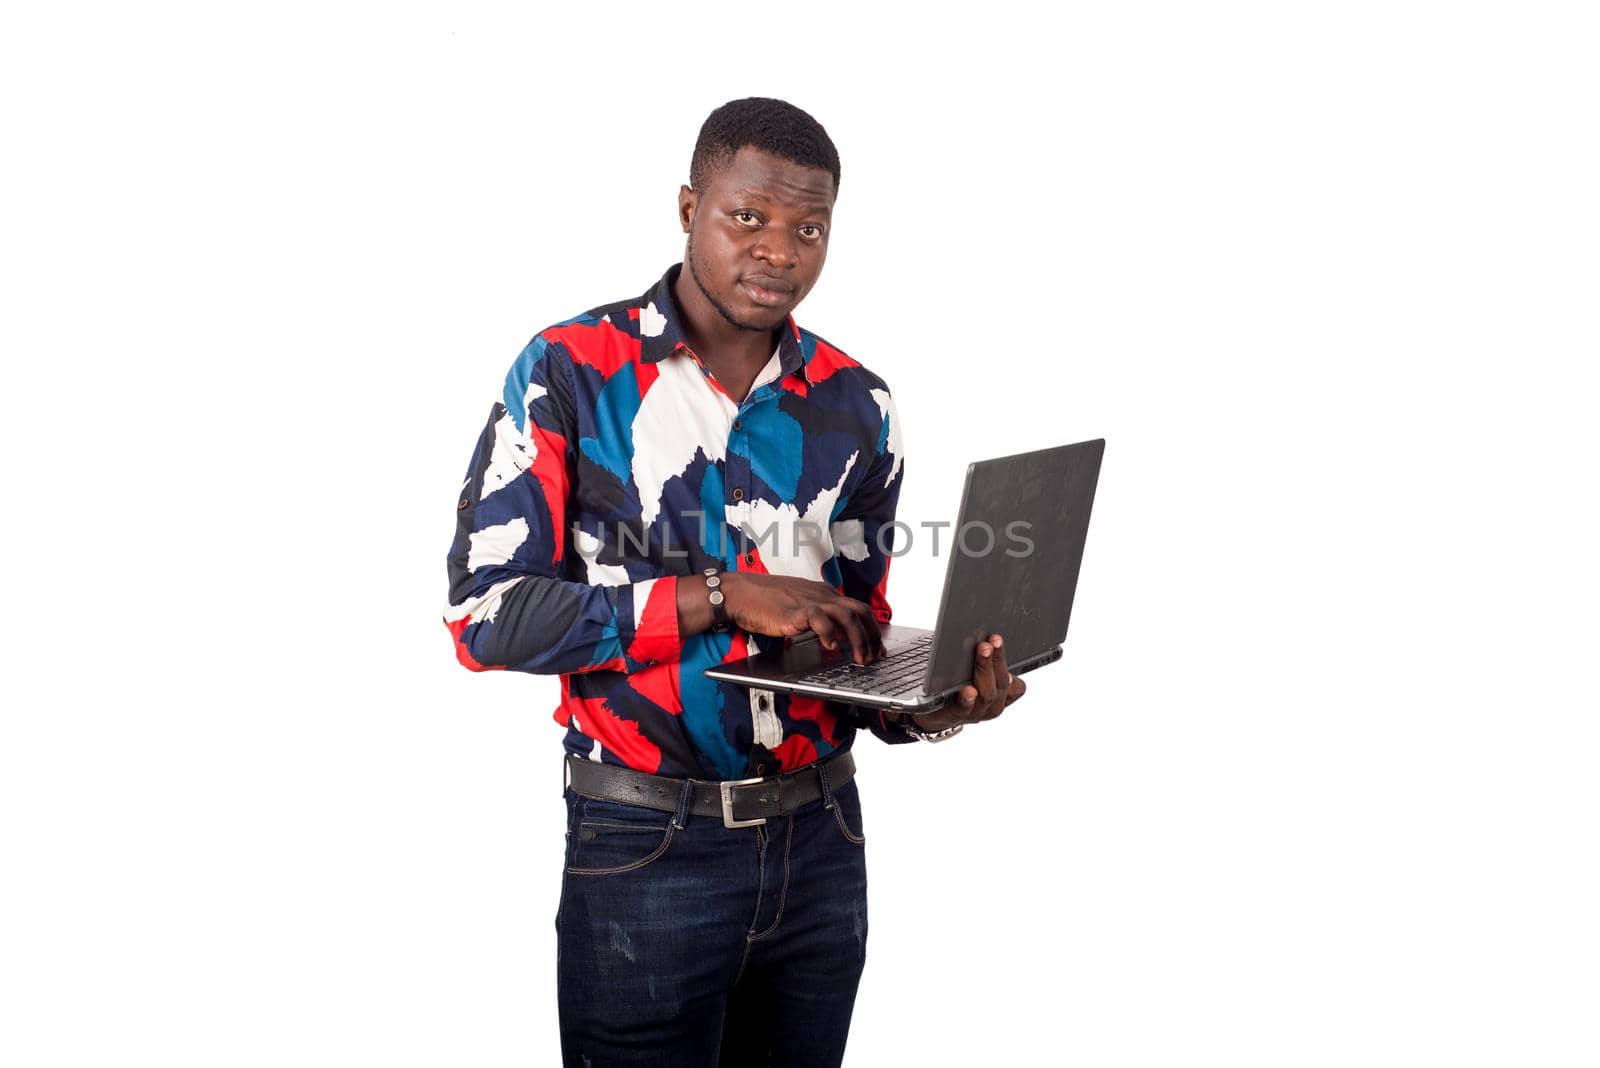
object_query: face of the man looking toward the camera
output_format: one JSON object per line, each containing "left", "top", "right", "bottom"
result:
{"left": 678, "top": 145, "right": 834, "bottom": 331}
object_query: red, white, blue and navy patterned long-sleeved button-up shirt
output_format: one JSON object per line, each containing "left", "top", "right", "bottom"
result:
{"left": 445, "top": 265, "right": 910, "bottom": 779}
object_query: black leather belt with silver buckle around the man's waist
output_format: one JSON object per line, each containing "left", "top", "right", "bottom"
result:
{"left": 566, "top": 750, "right": 856, "bottom": 827}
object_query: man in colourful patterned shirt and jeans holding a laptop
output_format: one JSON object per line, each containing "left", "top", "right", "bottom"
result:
{"left": 446, "top": 98, "right": 1024, "bottom": 1066}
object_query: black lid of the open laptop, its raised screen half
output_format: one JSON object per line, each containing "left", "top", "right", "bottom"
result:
{"left": 928, "top": 438, "right": 1106, "bottom": 694}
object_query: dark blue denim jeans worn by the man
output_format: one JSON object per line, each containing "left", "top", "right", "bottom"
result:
{"left": 555, "top": 764, "right": 867, "bottom": 1068}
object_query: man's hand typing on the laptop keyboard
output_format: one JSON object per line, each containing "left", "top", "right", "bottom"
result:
{"left": 722, "top": 571, "right": 883, "bottom": 664}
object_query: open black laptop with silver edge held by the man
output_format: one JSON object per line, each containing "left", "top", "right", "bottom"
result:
{"left": 706, "top": 438, "right": 1106, "bottom": 711}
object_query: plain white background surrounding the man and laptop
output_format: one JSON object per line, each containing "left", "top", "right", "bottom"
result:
{"left": 0, "top": 3, "right": 1600, "bottom": 1068}
